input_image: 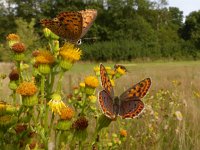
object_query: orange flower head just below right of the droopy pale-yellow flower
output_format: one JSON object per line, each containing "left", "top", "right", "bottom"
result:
{"left": 60, "top": 107, "right": 74, "bottom": 120}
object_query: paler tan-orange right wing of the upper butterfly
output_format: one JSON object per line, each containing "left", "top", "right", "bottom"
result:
{"left": 79, "top": 9, "right": 97, "bottom": 38}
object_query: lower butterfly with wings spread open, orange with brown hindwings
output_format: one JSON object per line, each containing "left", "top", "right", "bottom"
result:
{"left": 99, "top": 64, "right": 151, "bottom": 120}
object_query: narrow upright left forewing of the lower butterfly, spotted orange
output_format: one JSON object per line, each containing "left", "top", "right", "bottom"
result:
{"left": 100, "top": 64, "right": 114, "bottom": 99}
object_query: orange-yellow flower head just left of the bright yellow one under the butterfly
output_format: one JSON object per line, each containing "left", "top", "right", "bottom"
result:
{"left": 35, "top": 50, "right": 54, "bottom": 64}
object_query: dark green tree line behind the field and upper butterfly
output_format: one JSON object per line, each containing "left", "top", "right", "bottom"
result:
{"left": 0, "top": 0, "right": 200, "bottom": 61}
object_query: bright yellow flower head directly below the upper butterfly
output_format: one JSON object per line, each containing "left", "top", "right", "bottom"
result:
{"left": 60, "top": 43, "right": 82, "bottom": 62}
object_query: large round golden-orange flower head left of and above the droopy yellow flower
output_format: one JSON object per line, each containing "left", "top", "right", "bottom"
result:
{"left": 16, "top": 81, "right": 37, "bottom": 96}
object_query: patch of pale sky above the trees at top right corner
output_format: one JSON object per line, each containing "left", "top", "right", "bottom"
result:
{"left": 168, "top": 0, "right": 200, "bottom": 17}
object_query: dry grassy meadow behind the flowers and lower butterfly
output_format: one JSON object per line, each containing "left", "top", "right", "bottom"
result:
{"left": 0, "top": 61, "right": 200, "bottom": 150}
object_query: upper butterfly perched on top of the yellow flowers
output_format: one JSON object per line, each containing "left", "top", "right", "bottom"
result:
{"left": 40, "top": 9, "right": 97, "bottom": 43}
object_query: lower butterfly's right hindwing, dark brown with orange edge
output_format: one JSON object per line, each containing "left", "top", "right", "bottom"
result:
{"left": 119, "top": 99, "right": 144, "bottom": 119}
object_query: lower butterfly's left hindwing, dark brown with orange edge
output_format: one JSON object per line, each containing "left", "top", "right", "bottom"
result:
{"left": 99, "top": 90, "right": 117, "bottom": 119}
